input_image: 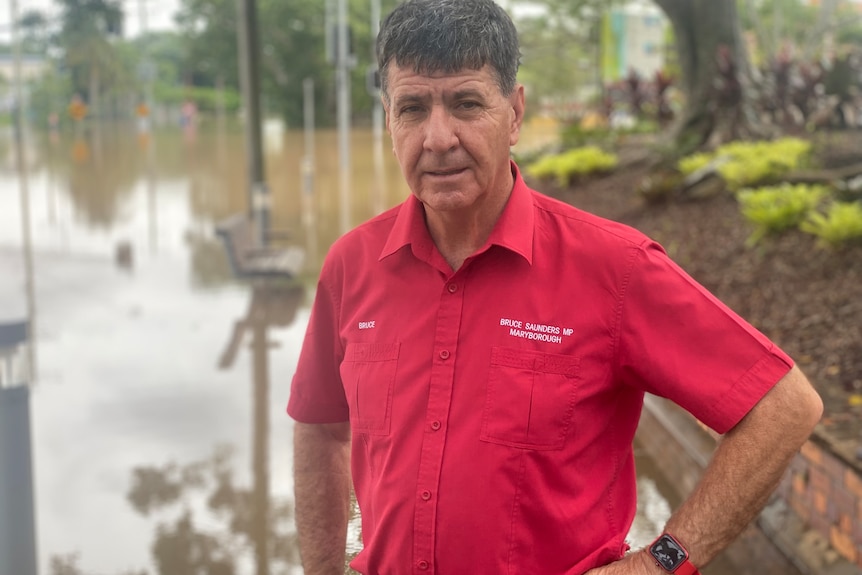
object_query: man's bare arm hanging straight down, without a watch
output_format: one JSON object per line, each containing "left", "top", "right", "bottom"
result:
{"left": 293, "top": 422, "right": 350, "bottom": 575}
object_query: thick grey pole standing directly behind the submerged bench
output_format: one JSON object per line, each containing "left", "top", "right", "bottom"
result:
{"left": 236, "top": 0, "right": 271, "bottom": 246}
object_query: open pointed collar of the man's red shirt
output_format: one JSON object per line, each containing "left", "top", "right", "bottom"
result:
{"left": 380, "top": 162, "right": 533, "bottom": 265}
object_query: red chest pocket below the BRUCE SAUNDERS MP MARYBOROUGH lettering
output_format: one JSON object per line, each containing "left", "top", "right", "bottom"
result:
{"left": 480, "top": 347, "right": 580, "bottom": 450}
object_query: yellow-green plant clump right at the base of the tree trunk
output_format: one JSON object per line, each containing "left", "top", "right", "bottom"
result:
{"left": 677, "top": 138, "right": 811, "bottom": 191}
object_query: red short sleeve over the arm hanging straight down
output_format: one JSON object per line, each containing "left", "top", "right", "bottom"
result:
{"left": 287, "top": 280, "right": 349, "bottom": 423}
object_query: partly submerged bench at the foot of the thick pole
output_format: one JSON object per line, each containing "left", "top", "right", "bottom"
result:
{"left": 216, "top": 214, "right": 305, "bottom": 278}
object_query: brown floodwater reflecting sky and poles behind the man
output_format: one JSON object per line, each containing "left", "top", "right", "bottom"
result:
{"left": 0, "top": 119, "right": 716, "bottom": 575}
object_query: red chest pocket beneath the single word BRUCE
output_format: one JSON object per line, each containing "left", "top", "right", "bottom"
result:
{"left": 341, "top": 343, "right": 401, "bottom": 435}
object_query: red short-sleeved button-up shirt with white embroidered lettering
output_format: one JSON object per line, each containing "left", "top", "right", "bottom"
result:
{"left": 288, "top": 164, "right": 792, "bottom": 575}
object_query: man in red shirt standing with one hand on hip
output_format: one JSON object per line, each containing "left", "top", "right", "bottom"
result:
{"left": 288, "top": 0, "right": 822, "bottom": 575}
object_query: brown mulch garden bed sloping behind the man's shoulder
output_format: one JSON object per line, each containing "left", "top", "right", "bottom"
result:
{"left": 531, "top": 134, "right": 862, "bottom": 471}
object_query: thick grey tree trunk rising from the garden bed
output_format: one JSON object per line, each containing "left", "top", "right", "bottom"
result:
{"left": 655, "top": 0, "right": 762, "bottom": 154}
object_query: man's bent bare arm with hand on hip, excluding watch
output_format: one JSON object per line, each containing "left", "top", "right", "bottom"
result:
{"left": 589, "top": 366, "right": 823, "bottom": 575}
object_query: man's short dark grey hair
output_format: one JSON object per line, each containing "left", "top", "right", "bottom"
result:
{"left": 377, "top": 0, "right": 521, "bottom": 102}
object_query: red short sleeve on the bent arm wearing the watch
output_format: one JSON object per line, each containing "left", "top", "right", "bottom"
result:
{"left": 617, "top": 242, "right": 793, "bottom": 433}
